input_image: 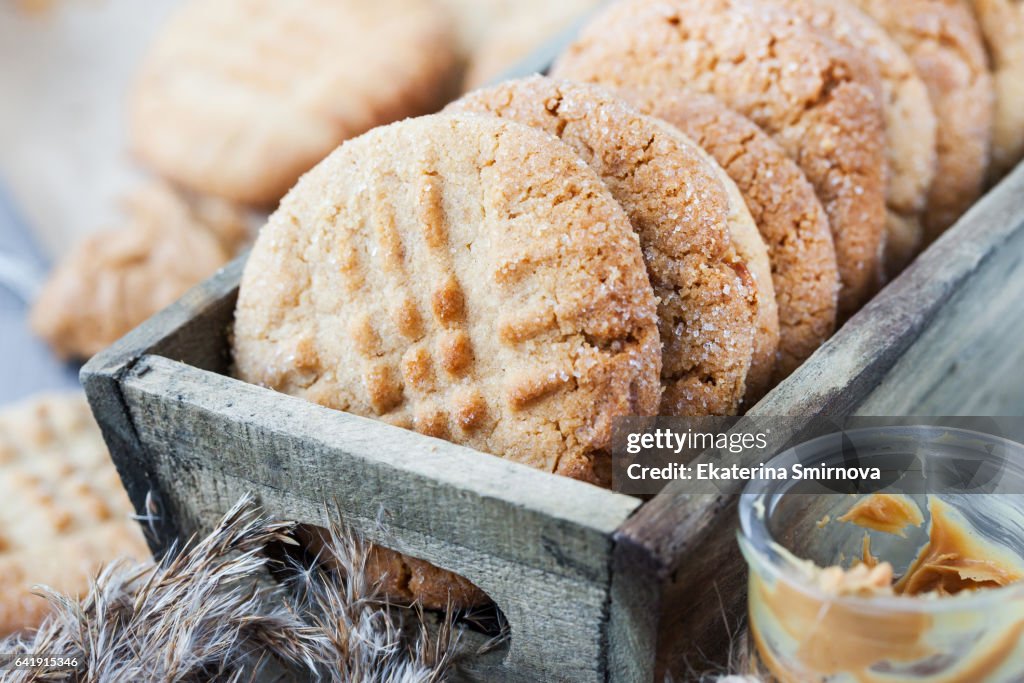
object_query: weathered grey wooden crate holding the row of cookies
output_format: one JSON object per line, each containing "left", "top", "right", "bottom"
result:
{"left": 82, "top": 154, "right": 1024, "bottom": 682}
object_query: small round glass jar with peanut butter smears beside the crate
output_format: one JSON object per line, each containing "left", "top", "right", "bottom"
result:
{"left": 739, "top": 427, "right": 1024, "bottom": 683}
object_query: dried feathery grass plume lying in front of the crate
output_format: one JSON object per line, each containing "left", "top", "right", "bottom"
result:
{"left": 0, "top": 499, "right": 457, "bottom": 683}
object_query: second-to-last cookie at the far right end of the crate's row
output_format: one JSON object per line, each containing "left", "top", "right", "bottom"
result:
{"left": 854, "top": 0, "right": 993, "bottom": 241}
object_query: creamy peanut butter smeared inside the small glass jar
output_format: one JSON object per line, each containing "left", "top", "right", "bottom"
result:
{"left": 743, "top": 495, "right": 1024, "bottom": 683}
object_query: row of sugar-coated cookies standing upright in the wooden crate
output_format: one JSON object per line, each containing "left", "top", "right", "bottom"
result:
{"left": 232, "top": 0, "right": 1024, "bottom": 607}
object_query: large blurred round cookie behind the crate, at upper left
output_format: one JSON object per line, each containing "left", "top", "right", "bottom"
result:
{"left": 129, "top": 0, "right": 457, "bottom": 205}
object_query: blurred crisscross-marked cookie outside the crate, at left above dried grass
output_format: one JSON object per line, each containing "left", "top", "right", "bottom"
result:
{"left": 0, "top": 394, "right": 150, "bottom": 637}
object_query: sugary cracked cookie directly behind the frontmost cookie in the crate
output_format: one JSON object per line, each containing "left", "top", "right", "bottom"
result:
{"left": 449, "top": 76, "right": 778, "bottom": 415}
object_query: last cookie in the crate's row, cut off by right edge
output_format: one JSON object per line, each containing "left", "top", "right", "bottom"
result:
{"left": 957, "top": 0, "right": 1024, "bottom": 182}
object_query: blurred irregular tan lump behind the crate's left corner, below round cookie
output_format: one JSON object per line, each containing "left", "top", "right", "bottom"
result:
{"left": 30, "top": 183, "right": 248, "bottom": 358}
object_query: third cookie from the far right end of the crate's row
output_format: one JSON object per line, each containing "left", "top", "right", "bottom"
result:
{"left": 773, "top": 0, "right": 938, "bottom": 278}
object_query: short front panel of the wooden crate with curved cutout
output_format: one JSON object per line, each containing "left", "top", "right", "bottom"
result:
{"left": 108, "top": 356, "right": 639, "bottom": 680}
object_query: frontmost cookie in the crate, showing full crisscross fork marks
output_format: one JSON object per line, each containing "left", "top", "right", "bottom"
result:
{"left": 232, "top": 114, "right": 662, "bottom": 607}
